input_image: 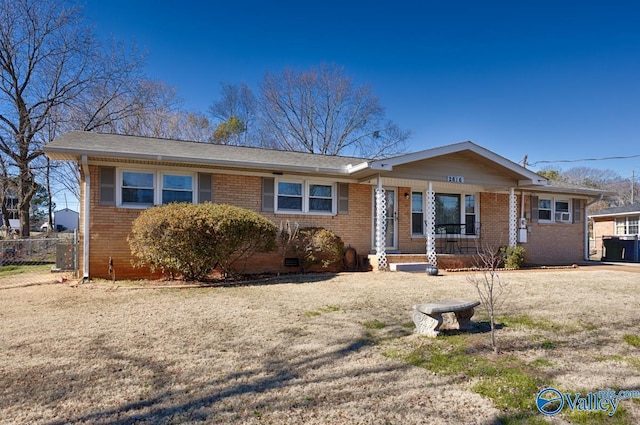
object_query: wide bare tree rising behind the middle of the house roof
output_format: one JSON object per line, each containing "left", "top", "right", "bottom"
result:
{"left": 259, "top": 65, "right": 410, "bottom": 158}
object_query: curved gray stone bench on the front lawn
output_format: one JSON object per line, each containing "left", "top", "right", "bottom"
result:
{"left": 413, "top": 300, "right": 480, "bottom": 337}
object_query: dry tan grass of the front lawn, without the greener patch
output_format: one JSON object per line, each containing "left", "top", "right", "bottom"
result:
{"left": 0, "top": 267, "right": 640, "bottom": 424}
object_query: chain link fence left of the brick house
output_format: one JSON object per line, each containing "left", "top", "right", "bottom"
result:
{"left": 0, "top": 232, "right": 78, "bottom": 289}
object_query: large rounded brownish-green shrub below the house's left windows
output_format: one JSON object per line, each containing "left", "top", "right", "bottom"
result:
{"left": 128, "top": 203, "right": 277, "bottom": 280}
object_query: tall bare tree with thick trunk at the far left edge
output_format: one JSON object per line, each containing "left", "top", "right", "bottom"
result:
{"left": 0, "top": 0, "right": 94, "bottom": 232}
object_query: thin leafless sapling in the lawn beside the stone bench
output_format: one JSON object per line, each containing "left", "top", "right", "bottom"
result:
{"left": 467, "top": 245, "right": 506, "bottom": 354}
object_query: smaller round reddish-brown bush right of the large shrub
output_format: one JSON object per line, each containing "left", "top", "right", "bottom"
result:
{"left": 292, "top": 227, "right": 344, "bottom": 271}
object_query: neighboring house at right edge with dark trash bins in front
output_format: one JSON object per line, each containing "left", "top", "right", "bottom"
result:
{"left": 589, "top": 203, "right": 640, "bottom": 262}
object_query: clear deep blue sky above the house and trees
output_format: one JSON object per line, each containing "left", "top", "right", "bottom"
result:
{"left": 84, "top": 0, "right": 640, "bottom": 177}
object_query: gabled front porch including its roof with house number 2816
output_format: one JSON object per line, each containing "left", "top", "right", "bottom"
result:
{"left": 360, "top": 142, "right": 548, "bottom": 270}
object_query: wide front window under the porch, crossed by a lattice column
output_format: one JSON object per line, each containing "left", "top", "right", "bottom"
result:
{"left": 411, "top": 192, "right": 479, "bottom": 236}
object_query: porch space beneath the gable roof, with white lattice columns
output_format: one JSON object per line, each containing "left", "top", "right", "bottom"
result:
{"left": 369, "top": 179, "right": 526, "bottom": 271}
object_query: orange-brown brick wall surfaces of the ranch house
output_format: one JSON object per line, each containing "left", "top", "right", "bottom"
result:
{"left": 80, "top": 166, "right": 583, "bottom": 278}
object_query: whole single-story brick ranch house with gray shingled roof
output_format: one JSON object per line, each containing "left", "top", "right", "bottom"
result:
{"left": 45, "top": 131, "right": 600, "bottom": 278}
